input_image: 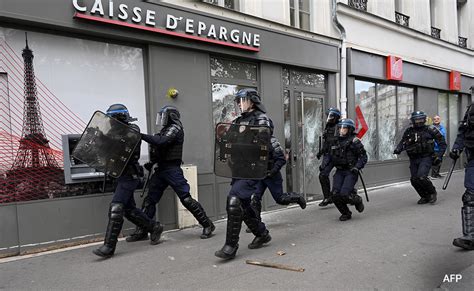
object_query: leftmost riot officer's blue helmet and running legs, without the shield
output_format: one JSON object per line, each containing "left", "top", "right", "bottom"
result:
{"left": 93, "top": 104, "right": 163, "bottom": 258}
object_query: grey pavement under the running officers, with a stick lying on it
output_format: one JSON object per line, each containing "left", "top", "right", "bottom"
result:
{"left": 0, "top": 171, "right": 474, "bottom": 290}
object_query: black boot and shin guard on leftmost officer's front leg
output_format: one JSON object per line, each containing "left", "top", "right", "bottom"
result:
{"left": 92, "top": 203, "right": 123, "bottom": 258}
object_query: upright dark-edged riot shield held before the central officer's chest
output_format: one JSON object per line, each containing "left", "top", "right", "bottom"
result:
{"left": 214, "top": 123, "right": 271, "bottom": 179}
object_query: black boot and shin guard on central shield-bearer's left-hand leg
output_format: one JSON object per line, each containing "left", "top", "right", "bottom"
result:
{"left": 214, "top": 196, "right": 243, "bottom": 260}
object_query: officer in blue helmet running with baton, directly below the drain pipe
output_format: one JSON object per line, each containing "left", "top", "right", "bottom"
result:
{"left": 329, "top": 119, "right": 367, "bottom": 221}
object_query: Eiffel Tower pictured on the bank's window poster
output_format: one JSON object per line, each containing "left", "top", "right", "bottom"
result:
{"left": 7, "top": 33, "right": 64, "bottom": 201}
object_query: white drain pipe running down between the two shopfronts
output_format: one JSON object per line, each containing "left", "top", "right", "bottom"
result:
{"left": 331, "top": 0, "right": 347, "bottom": 118}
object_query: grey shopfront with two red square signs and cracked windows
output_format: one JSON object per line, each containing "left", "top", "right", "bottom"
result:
{"left": 347, "top": 49, "right": 474, "bottom": 186}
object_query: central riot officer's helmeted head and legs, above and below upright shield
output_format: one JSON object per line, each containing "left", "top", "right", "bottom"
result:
{"left": 215, "top": 88, "right": 272, "bottom": 259}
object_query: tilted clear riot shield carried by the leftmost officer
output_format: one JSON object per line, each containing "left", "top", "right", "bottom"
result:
{"left": 72, "top": 111, "right": 141, "bottom": 178}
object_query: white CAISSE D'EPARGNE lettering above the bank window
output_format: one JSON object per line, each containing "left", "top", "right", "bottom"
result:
{"left": 71, "top": 0, "right": 260, "bottom": 51}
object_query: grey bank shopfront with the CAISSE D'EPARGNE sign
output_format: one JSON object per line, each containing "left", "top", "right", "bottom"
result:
{"left": 0, "top": 0, "right": 339, "bottom": 254}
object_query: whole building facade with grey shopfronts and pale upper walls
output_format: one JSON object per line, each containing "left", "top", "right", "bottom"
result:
{"left": 0, "top": 0, "right": 474, "bottom": 253}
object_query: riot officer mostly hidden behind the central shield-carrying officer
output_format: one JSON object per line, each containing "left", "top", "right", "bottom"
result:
{"left": 246, "top": 119, "right": 306, "bottom": 233}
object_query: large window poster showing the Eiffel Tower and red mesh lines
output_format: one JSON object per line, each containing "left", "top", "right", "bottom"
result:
{"left": 0, "top": 27, "right": 148, "bottom": 203}
